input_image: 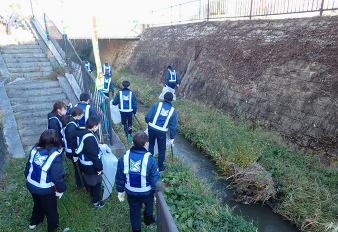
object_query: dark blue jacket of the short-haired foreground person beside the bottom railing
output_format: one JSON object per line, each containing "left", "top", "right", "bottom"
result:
{"left": 115, "top": 146, "right": 162, "bottom": 196}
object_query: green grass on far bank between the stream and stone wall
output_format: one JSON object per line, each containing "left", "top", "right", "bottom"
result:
{"left": 112, "top": 69, "right": 338, "bottom": 232}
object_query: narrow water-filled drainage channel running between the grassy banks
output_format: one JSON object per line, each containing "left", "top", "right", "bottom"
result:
{"left": 138, "top": 102, "right": 299, "bottom": 232}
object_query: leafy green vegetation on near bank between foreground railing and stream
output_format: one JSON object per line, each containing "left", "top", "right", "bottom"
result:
{"left": 114, "top": 112, "right": 257, "bottom": 232}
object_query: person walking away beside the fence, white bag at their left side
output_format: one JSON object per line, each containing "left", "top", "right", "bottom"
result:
{"left": 113, "top": 81, "right": 137, "bottom": 143}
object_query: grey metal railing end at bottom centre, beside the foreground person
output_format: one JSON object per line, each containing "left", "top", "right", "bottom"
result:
{"left": 156, "top": 182, "right": 178, "bottom": 232}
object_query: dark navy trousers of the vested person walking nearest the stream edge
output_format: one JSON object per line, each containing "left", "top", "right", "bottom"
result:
{"left": 148, "top": 127, "right": 167, "bottom": 171}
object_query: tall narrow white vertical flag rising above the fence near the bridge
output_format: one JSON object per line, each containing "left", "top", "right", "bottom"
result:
{"left": 92, "top": 16, "right": 104, "bottom": 90}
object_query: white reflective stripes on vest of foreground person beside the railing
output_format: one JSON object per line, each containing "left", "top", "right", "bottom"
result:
{"left": 123, "top": 150, "right": 151, "bottom": 193}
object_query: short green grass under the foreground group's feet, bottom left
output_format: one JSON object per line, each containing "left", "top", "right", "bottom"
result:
{"left": 0, "top": 159, "right": 156, "bottom": 232}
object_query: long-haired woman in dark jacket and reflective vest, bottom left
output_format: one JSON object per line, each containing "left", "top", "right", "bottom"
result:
{"left": 24, "top": 129, "right": 67, "bottom": 231}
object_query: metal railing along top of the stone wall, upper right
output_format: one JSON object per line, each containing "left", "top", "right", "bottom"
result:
{"left": 151, "top": 0, "right": 338, "bottom": 25}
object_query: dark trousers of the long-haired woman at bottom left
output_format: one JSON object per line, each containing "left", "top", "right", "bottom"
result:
{"left": 29, "top": 193, "right": 59, "bottom": 232}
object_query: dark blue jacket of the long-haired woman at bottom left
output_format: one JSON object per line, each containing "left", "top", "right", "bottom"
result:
{"left": 24, "top": 147, "right": 67, "bottom": 195}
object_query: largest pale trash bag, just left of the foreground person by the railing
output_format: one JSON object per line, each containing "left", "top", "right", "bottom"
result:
{"left": 100, "top": 144, "right": 118, "bottom": 200}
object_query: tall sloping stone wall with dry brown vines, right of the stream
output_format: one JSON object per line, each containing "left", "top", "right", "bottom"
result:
{"left": 127, "top": 17, "right": 338, "bottom": 165}
